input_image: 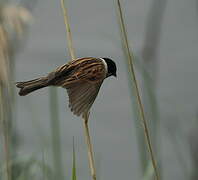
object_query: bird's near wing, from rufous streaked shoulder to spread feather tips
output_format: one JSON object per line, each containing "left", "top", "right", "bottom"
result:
{"left": 61, "top": 58, "right": 106, "bottom": 116}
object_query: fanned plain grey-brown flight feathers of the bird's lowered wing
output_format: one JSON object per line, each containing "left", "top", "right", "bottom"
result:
{"left": 66, "top": 81, "right": 102, "bottom": 116}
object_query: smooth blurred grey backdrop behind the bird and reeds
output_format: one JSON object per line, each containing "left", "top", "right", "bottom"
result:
{"left": 13, "top": 0, "right": 198, "bottom": 180}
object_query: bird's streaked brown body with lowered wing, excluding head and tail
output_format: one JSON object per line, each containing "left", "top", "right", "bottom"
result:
{"left": 48, "top": 57, "right": 107, "bottom": 116}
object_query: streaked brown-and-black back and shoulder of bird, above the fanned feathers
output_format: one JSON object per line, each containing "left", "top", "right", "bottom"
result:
{"left": 48, "top": 57, "right": 106, "bottom": 87}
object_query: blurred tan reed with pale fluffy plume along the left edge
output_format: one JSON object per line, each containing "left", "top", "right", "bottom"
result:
{"left": 0, "top": 3, "right": 31, "bottom": 180}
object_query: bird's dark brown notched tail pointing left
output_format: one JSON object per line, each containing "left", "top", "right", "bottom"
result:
{"left": 16, "top": 77, "right": 49, "bottom": 96}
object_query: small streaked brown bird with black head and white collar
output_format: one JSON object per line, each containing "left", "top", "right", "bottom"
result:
{"left": 16, "top": 57, "right": 117, "bottom": 116}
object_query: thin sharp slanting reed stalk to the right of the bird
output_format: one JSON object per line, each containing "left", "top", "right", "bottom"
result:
{"left": 117, "top": 0, "right": 159, "bottom": 180}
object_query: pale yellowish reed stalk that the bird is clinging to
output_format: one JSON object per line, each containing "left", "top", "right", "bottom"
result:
{"left": 61, "top": 0, "right": 96, "bottom": 180}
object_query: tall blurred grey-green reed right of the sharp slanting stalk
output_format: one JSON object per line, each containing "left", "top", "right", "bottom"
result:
{"left": 141, "top": 0, "right": 167, "bottom": 179}
